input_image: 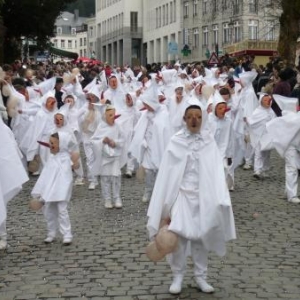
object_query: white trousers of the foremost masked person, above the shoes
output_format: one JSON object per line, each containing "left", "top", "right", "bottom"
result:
{"left": 168, "top": 236, "right": 208, "bottom": 279}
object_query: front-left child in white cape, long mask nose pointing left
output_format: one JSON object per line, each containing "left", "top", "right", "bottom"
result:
{"left": 31, "top": 132, "right": 73, "bottom": 245}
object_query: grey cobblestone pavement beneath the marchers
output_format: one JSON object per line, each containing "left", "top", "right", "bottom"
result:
{"left": 0, "top": 154, "right": 300, "bottom": 300}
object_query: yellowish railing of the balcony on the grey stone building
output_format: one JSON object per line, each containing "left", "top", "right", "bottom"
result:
{"left": 223, "top": 40, "right": 278, "bottom": 54}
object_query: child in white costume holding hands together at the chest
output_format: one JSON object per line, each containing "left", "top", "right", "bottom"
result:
{"left": 91, "top": 104, "right": 127, "bottom": 208}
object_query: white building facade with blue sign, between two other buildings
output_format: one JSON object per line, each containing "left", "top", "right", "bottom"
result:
{"left": 143, "top": 0, "right": 184, "bottom": 64}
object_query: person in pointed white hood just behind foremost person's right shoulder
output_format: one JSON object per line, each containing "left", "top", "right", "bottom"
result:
{"left": 208, "top": 91, "right": 234, "bottom": 191}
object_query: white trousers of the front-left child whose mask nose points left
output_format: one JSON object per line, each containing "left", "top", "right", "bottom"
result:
{"left": 43, "top": 201, "right": 72, "bottom": 238}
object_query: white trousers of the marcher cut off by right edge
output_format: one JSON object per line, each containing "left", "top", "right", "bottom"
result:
{"left": 285, "top": 148, "right": 300, "bottom": 200}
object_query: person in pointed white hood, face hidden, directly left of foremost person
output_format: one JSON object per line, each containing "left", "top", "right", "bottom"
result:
{"left": 128, "top": 84, "right": 171, "bottom": 202}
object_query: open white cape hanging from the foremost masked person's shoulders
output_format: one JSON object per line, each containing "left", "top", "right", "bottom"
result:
{"left": 147, "top": 130, "right": 236, "bottom": 256}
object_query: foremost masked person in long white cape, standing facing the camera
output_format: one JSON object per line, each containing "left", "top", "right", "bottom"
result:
{"left": 147, "top": 104, "right": 236, "bottom": 294}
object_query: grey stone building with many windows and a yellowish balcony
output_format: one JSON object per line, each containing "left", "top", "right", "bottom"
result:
{"left": 181, "top": 0, "right": 280, "bottom": 61}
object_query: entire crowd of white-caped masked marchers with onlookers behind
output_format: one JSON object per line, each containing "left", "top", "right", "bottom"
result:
{"left": 0, "top": 57, "right": 300, "bottom": 294}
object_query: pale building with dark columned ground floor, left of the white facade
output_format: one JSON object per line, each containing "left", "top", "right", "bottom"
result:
{"left": 96, "top": 0, "right": 144, "bottom": 65}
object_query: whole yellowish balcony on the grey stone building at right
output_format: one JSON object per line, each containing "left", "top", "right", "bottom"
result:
{"left": 223, "top": 40, "right": 278, "bottom": 56}
